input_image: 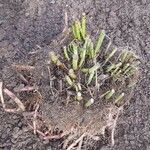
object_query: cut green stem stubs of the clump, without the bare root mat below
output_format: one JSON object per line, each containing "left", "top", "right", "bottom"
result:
{"left": 49, "top": 15, "right": 138, "bottom": 108}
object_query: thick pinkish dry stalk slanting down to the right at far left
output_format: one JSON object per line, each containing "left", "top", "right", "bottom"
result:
{"left": 4, "top": 88, "right": 25, "bottom": 111}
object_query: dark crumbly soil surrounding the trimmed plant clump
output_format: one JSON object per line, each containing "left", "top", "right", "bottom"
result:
{"left": 0, "top": 0, "right": 150, "bottom": 150}
